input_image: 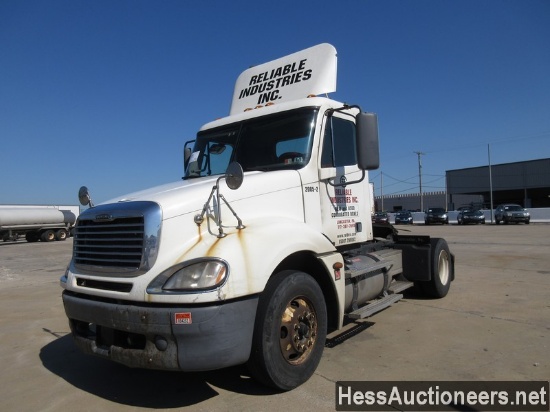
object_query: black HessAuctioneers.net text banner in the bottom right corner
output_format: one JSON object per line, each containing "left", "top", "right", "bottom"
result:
{"left": 336, "top": 381, "right": 550, "bottom": 412}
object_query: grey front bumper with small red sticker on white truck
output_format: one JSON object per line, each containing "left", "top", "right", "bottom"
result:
{"left": 63, "top": 291, "right": 258, "bottom": 371}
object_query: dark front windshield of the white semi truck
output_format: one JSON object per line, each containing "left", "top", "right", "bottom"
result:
{"left": 185, "top": 108, "right": 317, "bottom": 178}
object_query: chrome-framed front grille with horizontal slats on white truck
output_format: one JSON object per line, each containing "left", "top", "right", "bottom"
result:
{"left": 73, "top": 202, "right": 161, "bottom": 276}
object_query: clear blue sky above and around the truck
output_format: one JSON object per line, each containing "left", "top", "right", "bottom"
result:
{"left": 0, "top": 0, "right": 550, "bottom": 204}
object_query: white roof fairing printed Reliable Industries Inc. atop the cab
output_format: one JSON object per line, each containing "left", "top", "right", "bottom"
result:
{"left": 230, "top": 43, "right": 337, "bottom": 115}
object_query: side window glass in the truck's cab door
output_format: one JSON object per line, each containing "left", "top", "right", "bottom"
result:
{"left": 321, "top": 116, "right": 357, "bottom": 167}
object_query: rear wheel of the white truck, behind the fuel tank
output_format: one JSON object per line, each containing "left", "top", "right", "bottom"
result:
{"left": 419, "top": 238, "right": 454, "bottom": 298}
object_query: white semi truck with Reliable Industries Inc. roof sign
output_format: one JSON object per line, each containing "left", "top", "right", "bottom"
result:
{"left": 60, "top": 44, "right": 454, "bottom": 390}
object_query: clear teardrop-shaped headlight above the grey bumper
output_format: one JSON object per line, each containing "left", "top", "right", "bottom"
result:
{"left": 147, "top": 259, "right": 229, "bottom": 294}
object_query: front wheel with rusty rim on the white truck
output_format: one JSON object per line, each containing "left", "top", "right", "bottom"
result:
{"left": 248, "top": 270, "right": 327, "bottom": 390}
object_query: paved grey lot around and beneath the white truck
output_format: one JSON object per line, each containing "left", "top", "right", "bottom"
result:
{"left": 0, "top": 224, "right": 550, "bottom": 412}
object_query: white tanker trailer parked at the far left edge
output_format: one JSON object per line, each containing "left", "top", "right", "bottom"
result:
{"left": 0, "top": 205, "right": 78, "bottom": 242}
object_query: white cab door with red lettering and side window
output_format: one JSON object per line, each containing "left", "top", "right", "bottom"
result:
{"left": 319, "top": 112, "right": 372, "bottom": 247}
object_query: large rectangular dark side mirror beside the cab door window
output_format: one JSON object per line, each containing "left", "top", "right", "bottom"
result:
{"left": 355, "top": 113, "right": 380, "bottom": 170}
